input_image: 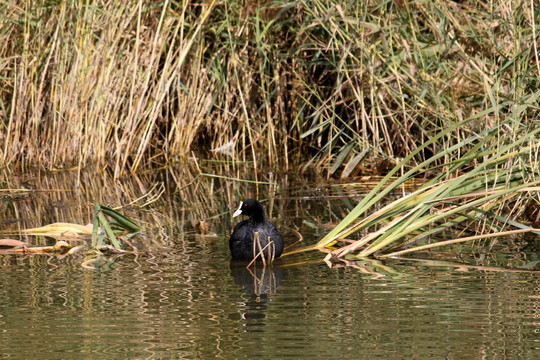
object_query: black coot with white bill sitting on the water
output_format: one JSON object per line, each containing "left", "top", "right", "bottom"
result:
{"left": 229, "top": 199, "right": 283, "bottom": 260}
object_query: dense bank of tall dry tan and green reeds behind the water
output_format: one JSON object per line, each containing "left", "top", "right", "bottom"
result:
{"left": 0, "top": 0, "right": 540, "bottom": 176}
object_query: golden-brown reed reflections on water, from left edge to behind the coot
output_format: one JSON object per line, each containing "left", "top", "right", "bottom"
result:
{"left": 0, "top": 164, "right": 301, "bottom": 247}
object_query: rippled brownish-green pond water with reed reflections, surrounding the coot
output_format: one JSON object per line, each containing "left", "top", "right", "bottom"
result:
{"left": 0, "top": 167, "right": 540, "bottom": 359}
